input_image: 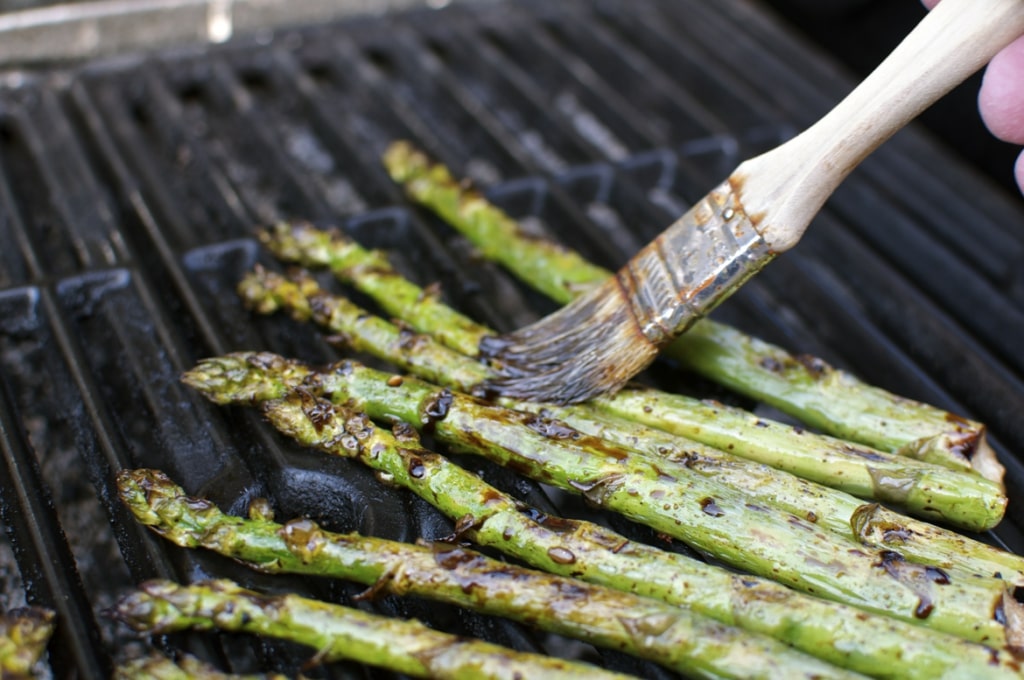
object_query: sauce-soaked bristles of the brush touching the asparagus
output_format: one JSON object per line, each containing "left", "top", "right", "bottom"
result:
{"left": 480, "top": 278, "right": 658, "bottom": 403}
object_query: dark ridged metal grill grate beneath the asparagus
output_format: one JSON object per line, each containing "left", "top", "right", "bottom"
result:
{"left": 0, "top": 0, "right": 1024, "bottom": 678}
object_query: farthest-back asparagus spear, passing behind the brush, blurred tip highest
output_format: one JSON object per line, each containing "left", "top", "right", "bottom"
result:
{"left": 384, "top": 142, "right": 1004, "bottom": 482}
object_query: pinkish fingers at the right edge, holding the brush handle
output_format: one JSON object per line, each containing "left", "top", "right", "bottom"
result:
{"left": 922, "top": 0, "right": 1024, "bottom": 193}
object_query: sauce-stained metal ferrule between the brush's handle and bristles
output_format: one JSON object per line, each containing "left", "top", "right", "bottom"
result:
{"left": 616, "top": 181, "right": 775, "bottom": 346}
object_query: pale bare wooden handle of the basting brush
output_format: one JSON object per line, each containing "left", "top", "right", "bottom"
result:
{"left": 730, "top": 0, "right": 1024, "bottom": 251}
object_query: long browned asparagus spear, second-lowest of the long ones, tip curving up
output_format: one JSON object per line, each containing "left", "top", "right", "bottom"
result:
{"left": 118, "top": 466, "right": 864, "bottom": 678}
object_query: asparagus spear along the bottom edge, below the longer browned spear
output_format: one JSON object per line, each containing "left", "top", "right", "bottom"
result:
{"left": 117, "top": 580, "right": 626, "bottom": 680}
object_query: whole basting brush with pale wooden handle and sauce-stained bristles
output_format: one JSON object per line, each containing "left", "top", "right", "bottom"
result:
{"left": 480, "top": 0, "right": 1024, "bottom": 403}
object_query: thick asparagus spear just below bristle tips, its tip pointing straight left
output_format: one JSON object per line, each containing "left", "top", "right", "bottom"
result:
{"left": 186, "top": 354, "right": 1006, "bottom": 645}
